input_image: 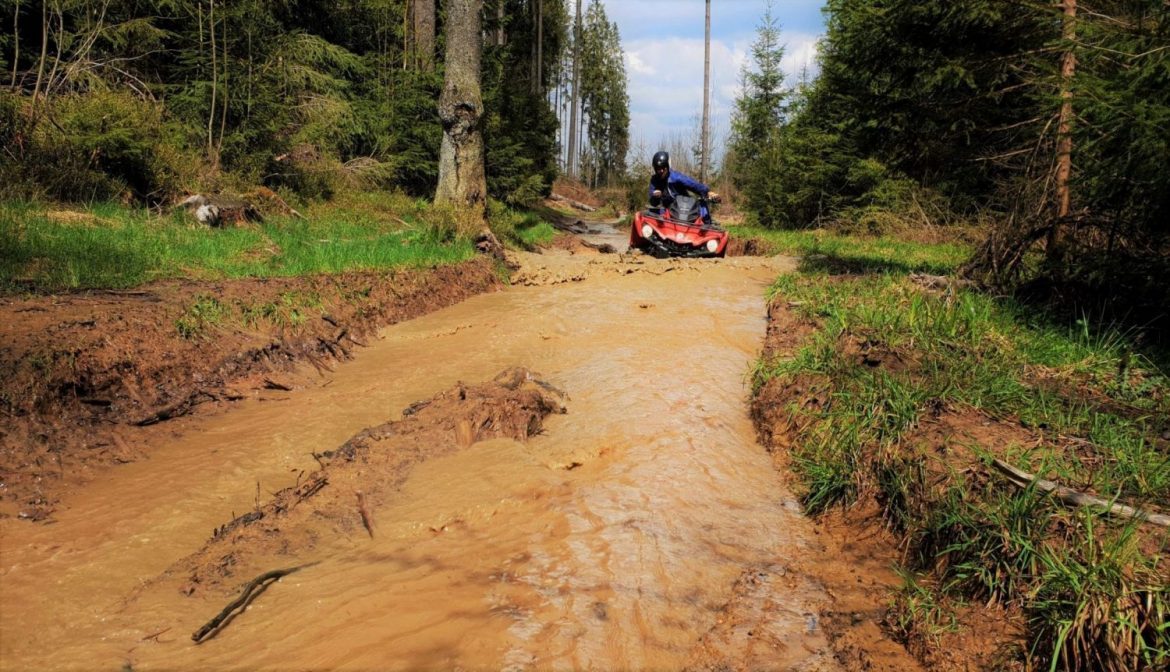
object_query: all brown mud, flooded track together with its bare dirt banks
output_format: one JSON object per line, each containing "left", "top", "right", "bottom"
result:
{"left": 0, "top": 220, "right": 940, "bottom": 671}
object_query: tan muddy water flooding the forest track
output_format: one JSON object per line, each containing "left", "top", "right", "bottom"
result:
{"left": 0, "top": 244, "right": 832, "bottom": 670}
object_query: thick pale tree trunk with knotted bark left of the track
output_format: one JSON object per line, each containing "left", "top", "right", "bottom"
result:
{"left": 435, "top": 0, "right": 488, "bottom": 234}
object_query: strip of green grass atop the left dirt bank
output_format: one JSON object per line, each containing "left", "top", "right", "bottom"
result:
{"left": 0, "top": 194, "right": 503, "bottom": 290}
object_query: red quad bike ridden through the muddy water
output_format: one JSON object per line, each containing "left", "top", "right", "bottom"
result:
{"left": 629, "top": 194, "right": 728, "bottom": 259}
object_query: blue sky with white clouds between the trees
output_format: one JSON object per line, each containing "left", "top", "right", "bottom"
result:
{"left": 599, "top": 0, "right": 825, "bottom": 163}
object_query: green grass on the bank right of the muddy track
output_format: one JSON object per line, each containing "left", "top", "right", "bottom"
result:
{"left": 753, "top": 239, "right": 1170, "bottom": 670}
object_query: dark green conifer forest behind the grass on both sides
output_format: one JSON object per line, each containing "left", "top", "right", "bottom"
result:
{"left": 0, "top": 0, "right": 1170, "bottom": 334}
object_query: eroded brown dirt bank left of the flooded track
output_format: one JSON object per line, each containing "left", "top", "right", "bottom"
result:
{"left": 0, "top": 259, "right": 502, "bottom": 520}
